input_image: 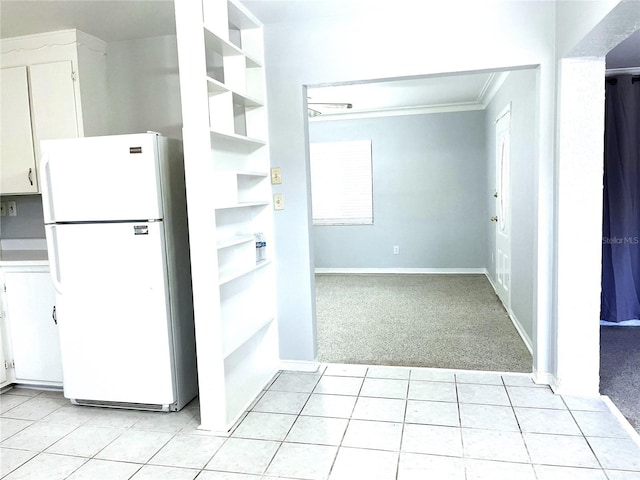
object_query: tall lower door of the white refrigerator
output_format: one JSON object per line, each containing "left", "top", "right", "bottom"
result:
{"left": 46, "top": 222, "right": 175, "bottom": 408}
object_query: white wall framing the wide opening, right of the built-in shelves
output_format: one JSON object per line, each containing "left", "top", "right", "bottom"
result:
{"left": 246, "top": 1, "right": 555, "bottom": 371}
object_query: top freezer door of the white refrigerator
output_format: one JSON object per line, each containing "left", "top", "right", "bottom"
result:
{"left": 40, "top": 133, "right": 163, "bottom": 223}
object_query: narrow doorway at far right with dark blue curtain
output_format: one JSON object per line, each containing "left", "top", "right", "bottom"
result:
{"left": 600, "top": 30, "right": 640, "bottom": 432}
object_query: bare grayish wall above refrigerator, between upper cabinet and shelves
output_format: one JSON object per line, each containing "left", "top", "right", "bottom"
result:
{"left": 107, "top": 35, "right": 182, "bottom": 138}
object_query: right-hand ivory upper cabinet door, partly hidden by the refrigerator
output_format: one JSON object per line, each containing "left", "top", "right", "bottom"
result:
{"left": 29, "top": 61, "right": 78, "bottom": 168}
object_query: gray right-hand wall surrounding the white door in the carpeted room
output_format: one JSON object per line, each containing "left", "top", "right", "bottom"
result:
{"left": 484, "top": 69, "right": 538, "bottom": 344}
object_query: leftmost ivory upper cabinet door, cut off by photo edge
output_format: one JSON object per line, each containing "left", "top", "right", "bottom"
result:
{"left": 0, "top": 67, "right": 38, "bottom": 195}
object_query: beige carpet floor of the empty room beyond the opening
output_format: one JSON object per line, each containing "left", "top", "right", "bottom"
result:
{"left": 316, "top": 274, "right": 532, "bottom": 372}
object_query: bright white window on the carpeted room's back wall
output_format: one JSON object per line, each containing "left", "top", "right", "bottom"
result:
{"left": 309, "top": 140, "right": 373, "bottom": 225}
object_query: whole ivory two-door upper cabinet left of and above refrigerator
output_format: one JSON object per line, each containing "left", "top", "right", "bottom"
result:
{"left": 0, "top": 30, "right": 108, "bottom": 195}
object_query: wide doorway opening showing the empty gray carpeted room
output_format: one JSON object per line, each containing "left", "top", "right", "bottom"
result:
{"left": 305, "top": 66, "right": 539, "bottom": 372}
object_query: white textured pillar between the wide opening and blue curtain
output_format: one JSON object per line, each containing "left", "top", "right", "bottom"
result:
{"left": 551, "top": 1, "right": 640, "bottom": 394}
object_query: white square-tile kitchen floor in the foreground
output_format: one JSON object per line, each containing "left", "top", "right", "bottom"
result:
{"left": 0, "top": 365, "right": 640, "bottom": 480}
